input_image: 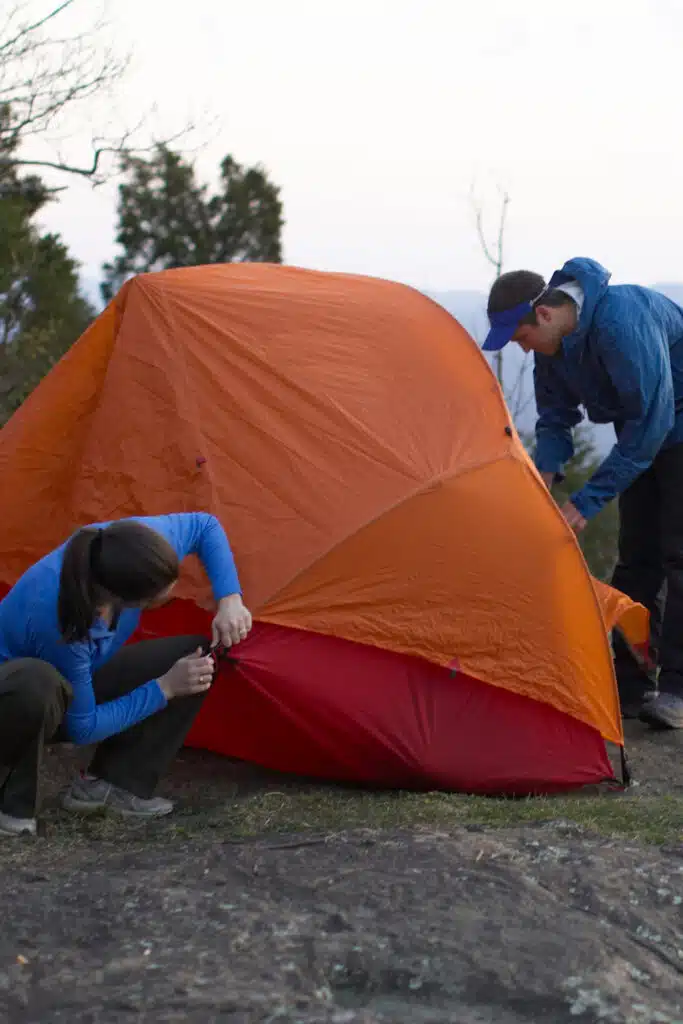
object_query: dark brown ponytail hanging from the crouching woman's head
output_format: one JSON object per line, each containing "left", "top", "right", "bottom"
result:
{"left": 57, "top": 526, "right": 101, "bottom": 643}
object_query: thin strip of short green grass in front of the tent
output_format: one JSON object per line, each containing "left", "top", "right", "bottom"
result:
{"left": 49, "top": 786, "right": 683, "bottom": 844}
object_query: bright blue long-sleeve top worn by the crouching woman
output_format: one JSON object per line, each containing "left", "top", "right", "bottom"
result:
{"left": 0, "top": 512, "right": 241, "bottom": 743}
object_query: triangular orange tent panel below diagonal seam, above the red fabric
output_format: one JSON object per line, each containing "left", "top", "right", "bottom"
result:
{"left": 260, "top": 458, "right": 622, "bottom": 742}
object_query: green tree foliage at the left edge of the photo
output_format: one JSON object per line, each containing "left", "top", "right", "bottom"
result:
{"left": 0, "top": 124, "right": 93, "bottom": 423}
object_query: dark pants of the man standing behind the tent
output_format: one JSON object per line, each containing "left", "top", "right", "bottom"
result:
{"left": 612, "top": 444, "right": 683, "bottom": 702}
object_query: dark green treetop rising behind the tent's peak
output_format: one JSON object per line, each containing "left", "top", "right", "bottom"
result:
{"left": 102, "top": 145, "right": 283, "bottom": 301}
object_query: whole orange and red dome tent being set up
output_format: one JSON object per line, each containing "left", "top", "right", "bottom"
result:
{"left": 0, "top": 264, "right": 646, "bottom": 792}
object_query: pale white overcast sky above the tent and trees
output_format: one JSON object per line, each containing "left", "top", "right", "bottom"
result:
{"left": 36, "top": 0, "right": 683, "bottom": 290}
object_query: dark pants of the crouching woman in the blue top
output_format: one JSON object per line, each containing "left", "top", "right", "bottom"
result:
{"left": 0, "top": 637, "right": 206, "bottom": 818}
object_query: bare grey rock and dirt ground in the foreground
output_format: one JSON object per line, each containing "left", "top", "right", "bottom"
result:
{"left": 0, "top": 725, "right": 683, "bottom": 1024}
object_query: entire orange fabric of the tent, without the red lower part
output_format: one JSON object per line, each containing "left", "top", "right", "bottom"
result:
{"left": 0, "top": 264, "right": 643, "bottom": 738}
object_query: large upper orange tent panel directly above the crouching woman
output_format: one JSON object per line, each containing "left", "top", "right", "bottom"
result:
{"left": 15, "top": 264, "right": 518, "bottom": 608}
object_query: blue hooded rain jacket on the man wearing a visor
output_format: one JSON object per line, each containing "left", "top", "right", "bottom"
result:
{"left": 535, "top": 259, "right": 683, "bottom": 518}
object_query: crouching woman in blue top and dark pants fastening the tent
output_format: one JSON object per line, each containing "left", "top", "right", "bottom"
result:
{"left": 0, "top": 513, "right": 252, "bottom": 836}
